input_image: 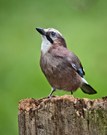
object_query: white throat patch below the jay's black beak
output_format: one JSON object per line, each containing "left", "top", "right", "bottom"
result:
{"left": 41, "top": 36, "right": 52, "bottom": 54}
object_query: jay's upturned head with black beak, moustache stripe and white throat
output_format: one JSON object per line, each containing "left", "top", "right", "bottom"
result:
{"left": 36, "top": 28, "right": 66, "bottom": 54}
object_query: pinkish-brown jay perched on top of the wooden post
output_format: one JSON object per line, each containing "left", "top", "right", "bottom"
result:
{"left": 36, "top": 28, "right": 97, "bottom": 97}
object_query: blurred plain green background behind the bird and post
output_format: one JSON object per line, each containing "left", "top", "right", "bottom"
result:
{"left": 0, "top": 0, "right": 107, "bottom": 135}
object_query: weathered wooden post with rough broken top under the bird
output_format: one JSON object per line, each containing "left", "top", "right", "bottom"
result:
{"left": 18, "top": 95, "right": 107, "bottom": 135}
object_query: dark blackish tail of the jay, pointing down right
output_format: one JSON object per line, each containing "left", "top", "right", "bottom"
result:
{"left": 81, "top": 83, "right": 97, "bottom": 94}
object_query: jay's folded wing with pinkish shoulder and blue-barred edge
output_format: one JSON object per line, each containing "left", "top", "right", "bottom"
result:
{"left": 52, "top": 46, "right": 85, "bottom": 77}
